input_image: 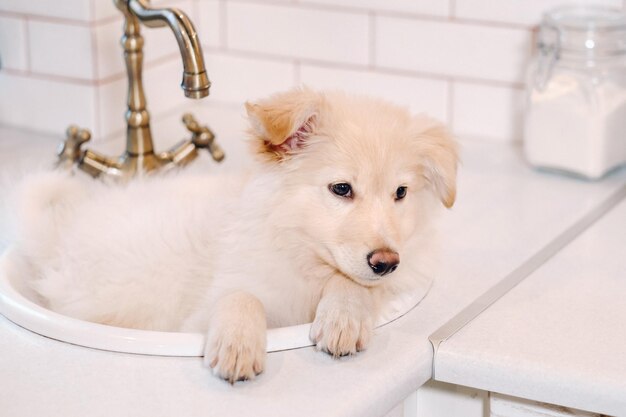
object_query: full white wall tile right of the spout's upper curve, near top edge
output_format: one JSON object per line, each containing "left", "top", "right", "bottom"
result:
{"left": 227, "top": 2, "right": 369, "bottom": 64}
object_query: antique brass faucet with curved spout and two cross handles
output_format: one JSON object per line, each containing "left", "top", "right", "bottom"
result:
{"left": 57, "top": 0, "right": 224, "bottom": 178}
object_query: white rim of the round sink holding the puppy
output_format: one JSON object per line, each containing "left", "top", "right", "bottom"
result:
{"left": 0, "top": 249, "right": 428, "bottom": 356}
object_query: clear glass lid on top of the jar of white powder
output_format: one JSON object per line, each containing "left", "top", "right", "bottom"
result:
{"left": 539, "top": 6, "right": 626, "bottom": 57}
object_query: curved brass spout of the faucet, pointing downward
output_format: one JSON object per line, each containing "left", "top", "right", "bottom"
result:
{"left": 127, "top": 0, "right": 211, "bottom": 99}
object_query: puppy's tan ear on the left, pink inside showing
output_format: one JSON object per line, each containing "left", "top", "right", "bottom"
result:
{"left": 246, "top": 88, "right": 322, "bottom": 161}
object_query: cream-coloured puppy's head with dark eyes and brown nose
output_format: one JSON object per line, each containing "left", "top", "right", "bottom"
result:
{"left": 246, "top": 89, "right": 457, "bottom": 286}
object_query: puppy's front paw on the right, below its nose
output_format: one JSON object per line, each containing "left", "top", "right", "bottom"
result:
{"left": 309, "top": 308, "right": 373, "bottom": 357}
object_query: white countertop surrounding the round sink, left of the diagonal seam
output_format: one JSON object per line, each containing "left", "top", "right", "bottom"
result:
{"left": 0, "top": 117, "right": 626, "bottom": 417}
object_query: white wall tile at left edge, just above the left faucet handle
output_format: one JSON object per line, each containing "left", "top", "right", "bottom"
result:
{"left": 0, "top": 72, "right": 96, "bottom": 135}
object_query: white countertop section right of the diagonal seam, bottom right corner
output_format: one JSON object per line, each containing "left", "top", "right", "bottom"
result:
{"left": 435, "top": 200, "right": 626, "bottom": 416}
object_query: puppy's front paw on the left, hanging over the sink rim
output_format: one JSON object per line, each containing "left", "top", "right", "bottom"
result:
{"left": 204, "top": 328, "right": 265, "bottom": 384}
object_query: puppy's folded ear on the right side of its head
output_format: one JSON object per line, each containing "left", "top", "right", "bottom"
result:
{"left": 416, "top": 117, "right": 458, "bottom": 208}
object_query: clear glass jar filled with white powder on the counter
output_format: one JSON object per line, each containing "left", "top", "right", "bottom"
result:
{"left": 524, "top": 7, "right": 626, "bottom": 179}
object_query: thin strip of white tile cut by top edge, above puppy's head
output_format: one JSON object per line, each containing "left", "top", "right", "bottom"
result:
{"left": 300, "top": 0, "right": 450, "bottom": 16}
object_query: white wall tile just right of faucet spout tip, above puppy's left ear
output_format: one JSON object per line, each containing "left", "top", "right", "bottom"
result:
{"left": 205, "top": 53, "right": 294, "bottom": 104}
